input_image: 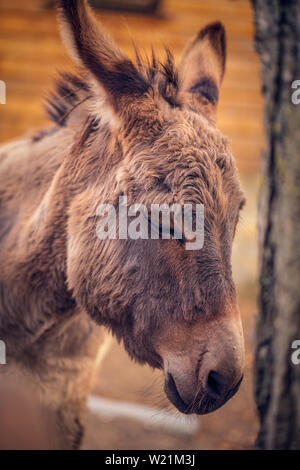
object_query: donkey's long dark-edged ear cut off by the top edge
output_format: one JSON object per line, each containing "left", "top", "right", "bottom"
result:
{"left": 59, "top": 0, "right": 148, "bottom": 112}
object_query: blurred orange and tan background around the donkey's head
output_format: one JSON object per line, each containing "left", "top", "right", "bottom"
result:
{"left": 0, "top": 0, "right": 264, "bottom": 449}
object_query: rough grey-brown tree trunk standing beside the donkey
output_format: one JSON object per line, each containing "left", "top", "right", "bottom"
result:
{"left": 252, "top": 0, "right": 300, "bottom": 449}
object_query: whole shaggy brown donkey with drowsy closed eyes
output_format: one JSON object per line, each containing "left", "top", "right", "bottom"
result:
{"left": 0, "top": 0, "right": 245, "bottom": 448}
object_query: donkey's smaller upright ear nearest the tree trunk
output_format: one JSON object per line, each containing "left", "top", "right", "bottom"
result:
{"left": 179, "top": 22, "right": 226, "bottom": 120}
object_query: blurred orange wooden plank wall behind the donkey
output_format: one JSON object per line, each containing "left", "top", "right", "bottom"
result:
{"left": 0, "top": 0, "right": 263, "bottom": 173}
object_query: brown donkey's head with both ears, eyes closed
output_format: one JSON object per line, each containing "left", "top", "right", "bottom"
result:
{"left": 60, "top": 0, "right": 244, "bottom": 414}
